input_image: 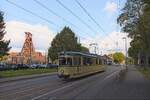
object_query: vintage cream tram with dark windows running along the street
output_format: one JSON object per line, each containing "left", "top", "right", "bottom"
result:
{"left": 58, "top": 51, "right": 105, "bottom": 78}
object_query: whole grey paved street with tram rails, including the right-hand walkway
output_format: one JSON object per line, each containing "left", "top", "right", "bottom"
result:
{"left": 0, "top": 66, "right": 150, "bottom": 100}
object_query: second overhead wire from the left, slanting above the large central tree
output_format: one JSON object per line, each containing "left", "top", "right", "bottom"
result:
{"left": 33, "top": 0, "right": 95, "bottom": 38}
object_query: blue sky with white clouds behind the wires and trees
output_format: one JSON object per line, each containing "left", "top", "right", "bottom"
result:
{"left": 0, "top": 0, "right": 130, "bottom": 54}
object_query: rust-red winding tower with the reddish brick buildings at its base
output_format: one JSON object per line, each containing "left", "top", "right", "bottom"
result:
{"left": 7, "top": 32, "right": 47, "bottom": 64}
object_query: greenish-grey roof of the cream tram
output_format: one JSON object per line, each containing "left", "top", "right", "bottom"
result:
{"left": 59, "top": 51, "right": 98, "bottom": 57}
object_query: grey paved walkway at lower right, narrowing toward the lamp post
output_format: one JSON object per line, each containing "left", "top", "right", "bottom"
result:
{"left": 100, "top": 66, "right": 150, "bottom": 100}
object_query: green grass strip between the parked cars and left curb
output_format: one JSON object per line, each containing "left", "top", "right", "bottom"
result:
{"left": 0, "top": 68, "right": 57, "bottom": 78}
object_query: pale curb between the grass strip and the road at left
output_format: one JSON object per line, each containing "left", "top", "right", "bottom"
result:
{"left": 0, "top": 72, "right": 57, "bottom": 84}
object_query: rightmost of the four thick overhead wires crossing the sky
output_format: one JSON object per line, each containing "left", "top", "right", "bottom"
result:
{"left": 75, "top": 0, "right": 105, "bottom": 33}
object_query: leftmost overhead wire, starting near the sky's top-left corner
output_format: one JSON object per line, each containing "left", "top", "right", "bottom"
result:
{"left": 6, "top": 0, "right": 59, "bottom": 27}
